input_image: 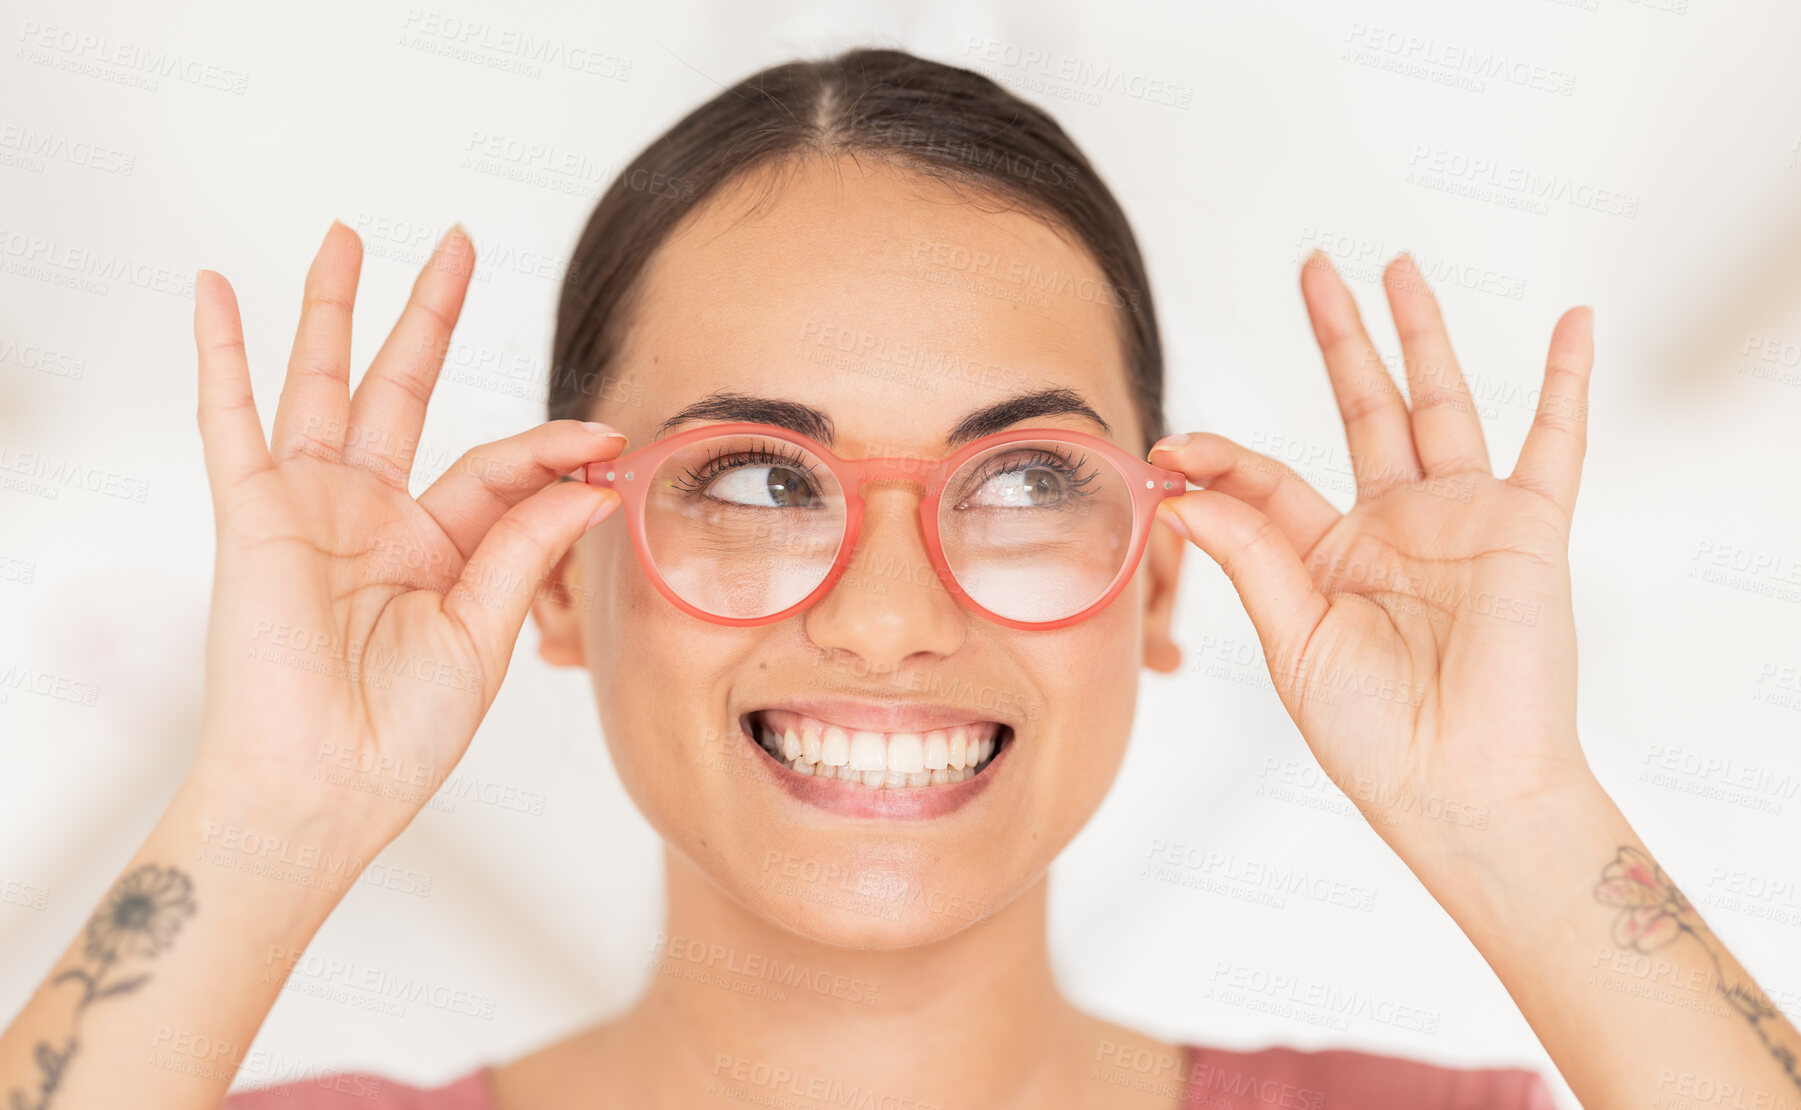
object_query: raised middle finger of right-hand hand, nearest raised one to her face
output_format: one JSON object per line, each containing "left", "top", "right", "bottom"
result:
{"left": 1300, "top": 250, "right": 1419, "bottom": 496}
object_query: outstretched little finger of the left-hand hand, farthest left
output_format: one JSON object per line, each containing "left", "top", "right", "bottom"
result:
{"left": 195, "top": 270, "right": 272, "bottom": 499}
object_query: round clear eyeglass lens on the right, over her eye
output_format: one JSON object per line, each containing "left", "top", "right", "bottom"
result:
{"left": 938, "top": 440, "right": 1133, "bottom": 622}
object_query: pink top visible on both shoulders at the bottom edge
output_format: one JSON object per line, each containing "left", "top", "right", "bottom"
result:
{"left": 222, "top": 1045, "right": 1556, "bottom": 1110}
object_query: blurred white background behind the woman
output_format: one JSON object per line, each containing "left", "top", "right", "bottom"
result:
{"left": 0, "top": 0, "right": 1801, "bottom": 1099}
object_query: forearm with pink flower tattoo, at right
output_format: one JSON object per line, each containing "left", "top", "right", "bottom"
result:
{"left": 1416, "top": 777, "right": 1801, "bottom": 1110}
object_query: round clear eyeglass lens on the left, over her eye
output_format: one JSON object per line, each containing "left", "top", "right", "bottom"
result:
{"left": 645, "top": 434, "right": 845, "bottom": 620}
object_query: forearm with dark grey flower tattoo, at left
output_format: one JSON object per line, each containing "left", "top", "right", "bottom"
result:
{"left": 0, "top": 780, "right": 367, "bottom": 1110}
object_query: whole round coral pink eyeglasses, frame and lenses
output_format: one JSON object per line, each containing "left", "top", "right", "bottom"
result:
{"left": 587, "top": 423, "right": 1187, "bottom": 629}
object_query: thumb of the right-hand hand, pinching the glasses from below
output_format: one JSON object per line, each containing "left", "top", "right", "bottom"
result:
{"left": 1156, "top": 490, "right": 1331, "bottom": 676}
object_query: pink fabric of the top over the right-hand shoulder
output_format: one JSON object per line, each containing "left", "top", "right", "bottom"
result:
{"left": 1185, "top": 1045, "right": 1556, "bottom": 1110}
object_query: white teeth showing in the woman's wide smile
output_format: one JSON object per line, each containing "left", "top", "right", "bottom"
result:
{"left": 756, "top": 710, "right": 1000, "bottom": 787}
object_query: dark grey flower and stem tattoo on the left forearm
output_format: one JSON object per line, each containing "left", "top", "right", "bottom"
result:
{"left": 5, "top": 863, "right": 195, "bottom": 1110}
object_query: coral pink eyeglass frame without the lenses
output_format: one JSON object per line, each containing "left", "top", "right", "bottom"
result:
{"left": 585, "top": 423, "right": 1189, "bottom": 631}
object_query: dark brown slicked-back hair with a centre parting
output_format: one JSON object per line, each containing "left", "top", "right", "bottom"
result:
{"left": 549, "top": 50, "right": 1163, "bottom": 447}
